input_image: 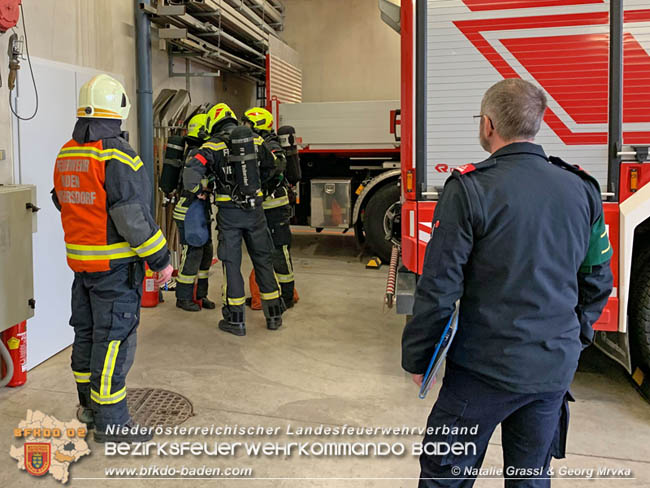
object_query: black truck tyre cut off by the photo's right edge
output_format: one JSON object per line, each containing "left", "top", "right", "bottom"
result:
{"left": 629, "top": 255, "right": 650, "bottom": 371}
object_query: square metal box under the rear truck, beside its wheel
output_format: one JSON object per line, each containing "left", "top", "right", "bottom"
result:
{"left": 310, "top": 179, "right": 352, "bottom": 229}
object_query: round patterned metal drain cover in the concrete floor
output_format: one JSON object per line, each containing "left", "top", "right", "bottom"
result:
{"left": 126, "top": 388, "right": 194, "bottom": 427}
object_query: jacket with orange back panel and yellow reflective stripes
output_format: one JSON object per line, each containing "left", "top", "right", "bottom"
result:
{"left": 52, "top": 119, "right": 169, "bottom": 272}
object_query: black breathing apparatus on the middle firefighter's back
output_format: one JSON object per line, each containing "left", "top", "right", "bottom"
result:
{"left": 218, "top": 126, "right": 262, "bottom": 208}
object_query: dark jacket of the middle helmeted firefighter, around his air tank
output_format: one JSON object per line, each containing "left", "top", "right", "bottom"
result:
{"left": 183, "top": 122, "right": 275, "bottom": 207}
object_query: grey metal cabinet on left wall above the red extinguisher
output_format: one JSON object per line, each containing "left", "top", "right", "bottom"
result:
{"left": 0, "top": 185, "right": 37, "bottom": 331}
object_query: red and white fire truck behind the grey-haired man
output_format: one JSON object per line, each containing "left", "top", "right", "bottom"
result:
{"left": 390, "top": 0, "right": 650, "bottom": 384}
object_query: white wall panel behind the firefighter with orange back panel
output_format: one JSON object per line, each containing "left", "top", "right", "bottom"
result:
{"left": 13, "top": 58, "right": 124, "bottom": 369}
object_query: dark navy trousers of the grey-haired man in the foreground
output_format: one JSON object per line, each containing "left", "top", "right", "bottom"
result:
{"left": 419, "top": 360, "right": 573, "bottom": 488}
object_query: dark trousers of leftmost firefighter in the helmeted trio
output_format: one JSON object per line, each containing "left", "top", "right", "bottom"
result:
{"left": 176, "top": 220, "right": 214, "bottom": 300}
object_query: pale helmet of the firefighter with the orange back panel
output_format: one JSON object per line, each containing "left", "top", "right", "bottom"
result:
{"left": 77, "top": 75, "right": 131, "bottom": 120}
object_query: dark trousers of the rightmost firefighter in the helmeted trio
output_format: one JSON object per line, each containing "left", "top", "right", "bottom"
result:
{"left": 264, "top": 205, "right": 295, "bottom": 306}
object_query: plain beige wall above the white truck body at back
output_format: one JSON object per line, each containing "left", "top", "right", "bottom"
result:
{"left": 283, "top": 0, "right": 400, "bottom": 102}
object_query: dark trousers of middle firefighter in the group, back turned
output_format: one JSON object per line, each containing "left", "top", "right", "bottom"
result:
{"left": 217, "top": 206, "right": 283, "bottom": 323}
